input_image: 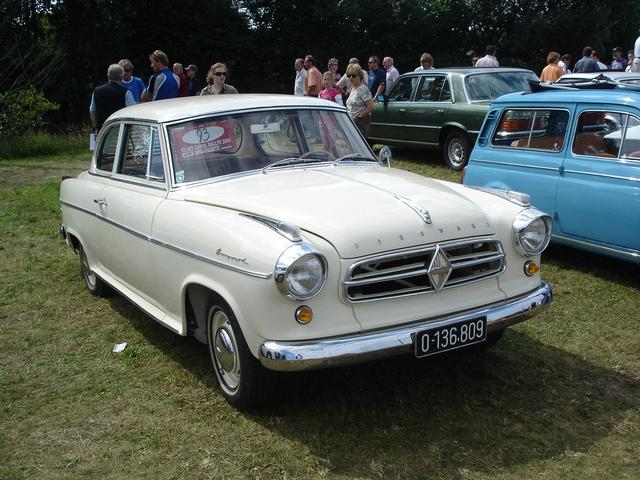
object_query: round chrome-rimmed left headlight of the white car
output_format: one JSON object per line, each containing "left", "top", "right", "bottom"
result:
{"left": 274, "top": 244, "right": 327, "bottom": 300}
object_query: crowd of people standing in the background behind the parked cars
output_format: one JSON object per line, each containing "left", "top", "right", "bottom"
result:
{"left": 89, "top": 37, "right": 640, "bottom": 136}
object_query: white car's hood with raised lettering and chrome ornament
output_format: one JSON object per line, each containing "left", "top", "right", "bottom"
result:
{"left": 184, "top": 166, "right": 494, "bottom": 258}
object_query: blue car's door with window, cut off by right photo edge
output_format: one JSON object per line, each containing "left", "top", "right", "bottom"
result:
{"left": 554, "top": 105, "right": 640, "bottom": 250}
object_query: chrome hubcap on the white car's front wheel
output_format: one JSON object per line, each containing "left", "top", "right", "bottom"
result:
{"left": 210, "top": 310, "right": 240, "bottom": 390}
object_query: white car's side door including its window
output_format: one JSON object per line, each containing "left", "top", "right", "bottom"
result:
{"left": 97, "top": 123, "right": 167, "bottom": 300}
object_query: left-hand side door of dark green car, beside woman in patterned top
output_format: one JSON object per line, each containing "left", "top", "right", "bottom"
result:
{"left": 369, "top": 75, "right": 419, "bottom": 143}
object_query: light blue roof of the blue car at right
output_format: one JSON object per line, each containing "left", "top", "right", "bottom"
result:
{"left": 493, "top": 87, "right": 640, "bottom": 108}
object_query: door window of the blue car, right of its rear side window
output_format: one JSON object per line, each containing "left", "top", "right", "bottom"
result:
{"left": 573, "top": 111, "right": 627, "bottom": 158}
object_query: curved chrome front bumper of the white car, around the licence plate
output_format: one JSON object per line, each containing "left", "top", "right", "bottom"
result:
{"left": 259, "top": 283, "right": 553, "bottom": 371}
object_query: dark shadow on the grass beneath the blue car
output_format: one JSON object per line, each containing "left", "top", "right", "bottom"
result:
{"left": 542, "top": 244, "right": 640, "bottom": 288}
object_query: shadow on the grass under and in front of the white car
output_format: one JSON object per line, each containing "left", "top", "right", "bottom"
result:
{"left": 112, "top": 297, "right": 640, "bottom": 478}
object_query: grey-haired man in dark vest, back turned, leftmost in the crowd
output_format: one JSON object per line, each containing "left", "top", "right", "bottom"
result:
{"left": 89, "top": 63, "right": 136, "bottom": 132}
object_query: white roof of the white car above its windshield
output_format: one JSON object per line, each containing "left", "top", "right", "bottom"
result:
{"left": 109, "top": 94, "right": 344, "bottom": 123}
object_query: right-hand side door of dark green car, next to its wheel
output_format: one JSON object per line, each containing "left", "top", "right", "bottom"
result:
{"left": 404, "top": 73, "right": 451, "bottom": 145}
